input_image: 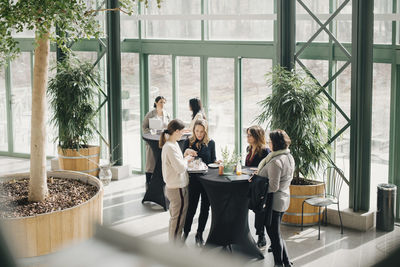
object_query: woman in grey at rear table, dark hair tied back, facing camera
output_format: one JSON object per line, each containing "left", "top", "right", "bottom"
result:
{"left": 142, "top": 96, "right": 171, "bottom": 190}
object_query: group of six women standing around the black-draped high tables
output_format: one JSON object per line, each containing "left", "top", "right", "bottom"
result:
{"left": 142, "top": 96, "right": 294, "bottom": 266}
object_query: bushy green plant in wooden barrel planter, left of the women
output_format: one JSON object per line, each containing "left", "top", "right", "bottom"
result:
{"left": 47, "top": 55, "right": 100, "bottom": 176}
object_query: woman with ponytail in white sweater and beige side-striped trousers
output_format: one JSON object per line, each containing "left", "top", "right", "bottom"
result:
{"left": 159, "top": 120, "right": 193, "bottom": 242}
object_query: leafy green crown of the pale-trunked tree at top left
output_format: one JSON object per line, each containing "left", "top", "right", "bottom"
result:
{"left": 0, "top": 0, "right": 161, "bottom": 66}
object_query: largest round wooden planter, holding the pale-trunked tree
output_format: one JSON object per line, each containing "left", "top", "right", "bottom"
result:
{"left": 0, "top": 171, "right": 103, "bottom": 257}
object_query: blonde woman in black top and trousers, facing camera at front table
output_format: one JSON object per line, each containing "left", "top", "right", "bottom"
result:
{"left": 183, "top": 120, "right": 216, "bottom": 247}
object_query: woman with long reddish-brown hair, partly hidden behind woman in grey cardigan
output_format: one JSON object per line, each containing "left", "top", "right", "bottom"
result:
{"left": 245, "top": 125, "right": 270, "bottom": 250}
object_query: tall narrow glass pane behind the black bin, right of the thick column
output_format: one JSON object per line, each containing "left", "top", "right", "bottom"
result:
{"left": 371, "top": 63, "right": 391, "bottom": 207}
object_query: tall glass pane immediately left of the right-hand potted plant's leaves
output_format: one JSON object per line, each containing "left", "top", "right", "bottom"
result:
{"left": 241, "top": 58, "right": 272, "bottom": 162}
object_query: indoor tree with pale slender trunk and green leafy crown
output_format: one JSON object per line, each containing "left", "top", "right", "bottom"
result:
{"left": 0, "top": 0, "right": 161, "bottom": 201}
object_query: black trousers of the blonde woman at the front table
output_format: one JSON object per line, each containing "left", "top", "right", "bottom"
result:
{"left": 183, "top": 174, "right": 210, "bottom": 234}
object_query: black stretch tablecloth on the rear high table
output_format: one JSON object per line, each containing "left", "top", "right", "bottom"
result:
{"left": 142, "top": 134, "right": 187, "bottom": 211}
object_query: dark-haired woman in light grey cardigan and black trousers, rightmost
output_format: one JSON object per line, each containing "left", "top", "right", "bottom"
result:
{"left": 258, "top": 130, "right": 295, "bottom": 266}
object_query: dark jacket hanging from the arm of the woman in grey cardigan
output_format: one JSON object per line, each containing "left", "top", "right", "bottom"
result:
{"left": 248, "top": 175, "right": 273, "bottom": 226}
